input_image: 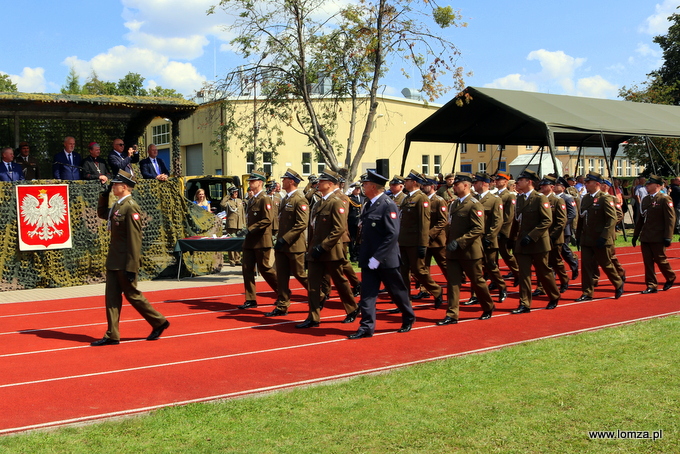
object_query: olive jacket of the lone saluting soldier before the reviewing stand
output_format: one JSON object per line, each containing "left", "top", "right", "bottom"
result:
{"left": 97, "top": 193, "right": 142, "bottom": 273}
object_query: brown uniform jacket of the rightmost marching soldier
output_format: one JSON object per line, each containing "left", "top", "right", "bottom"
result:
{"left": 633, "top": 192, "right": 675, "bottom": 243}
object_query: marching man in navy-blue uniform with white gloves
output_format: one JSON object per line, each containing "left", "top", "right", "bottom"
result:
{"left": 348, "top": 170, "right": 416, "bottom": 339}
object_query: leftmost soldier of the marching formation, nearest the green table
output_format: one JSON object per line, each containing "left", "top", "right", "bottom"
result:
{"left": 238, "top": 170, "right": 279, "bottom": 309}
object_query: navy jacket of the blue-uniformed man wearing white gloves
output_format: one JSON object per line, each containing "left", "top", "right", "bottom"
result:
{"left": 359, "top": 193, "right": 401, "bottom": 268}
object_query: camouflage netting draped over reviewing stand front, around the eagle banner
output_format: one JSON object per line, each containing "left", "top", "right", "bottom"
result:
{"left": 0, "top": 178, "right": 222, "bottom": 291}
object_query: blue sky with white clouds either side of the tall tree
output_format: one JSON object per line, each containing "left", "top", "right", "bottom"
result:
{"left": 0, "top": 0, "right": 680, "bottom": 103}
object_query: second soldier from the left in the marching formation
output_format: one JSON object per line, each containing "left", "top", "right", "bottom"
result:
{"left": 264, "top": 169, "right": 309, "bottom": 317}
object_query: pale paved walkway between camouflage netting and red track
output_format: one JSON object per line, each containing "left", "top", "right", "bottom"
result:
{"left": 0, "top": 265, "right": 246, "bottom": 304}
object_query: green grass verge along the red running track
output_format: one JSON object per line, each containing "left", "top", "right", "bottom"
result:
{"left": 0, "top": 317, "right": 680, "bottom": 454}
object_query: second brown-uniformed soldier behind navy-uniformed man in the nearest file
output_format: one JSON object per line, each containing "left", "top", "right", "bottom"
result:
{"left": 512, "top": 169, "right": 560, "bottom": 314}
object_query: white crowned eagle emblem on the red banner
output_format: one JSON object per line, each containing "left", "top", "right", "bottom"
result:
{"left": 21, "top": 189, "right": 66, "bottom": 240}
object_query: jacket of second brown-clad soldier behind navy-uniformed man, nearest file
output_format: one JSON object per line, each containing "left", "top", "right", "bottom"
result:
{"left": 511, "top": 190, "right": 552, "bottom": 254}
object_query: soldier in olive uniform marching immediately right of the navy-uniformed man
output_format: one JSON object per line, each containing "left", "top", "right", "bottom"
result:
{"left": 399, "top": 170, "right": 442, "bottom": 308}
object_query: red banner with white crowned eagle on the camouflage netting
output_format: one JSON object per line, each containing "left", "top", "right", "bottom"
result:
{"left": 16, "top": 184, "right": 72, "bottom": 251}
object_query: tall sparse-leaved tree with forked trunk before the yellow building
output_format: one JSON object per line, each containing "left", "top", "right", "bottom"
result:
{"left": 208, "top": 0, "right": 465, "bottom": 179}
